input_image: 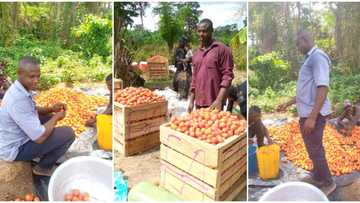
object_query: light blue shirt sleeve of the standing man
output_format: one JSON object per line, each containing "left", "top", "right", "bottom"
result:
{"left": 312, "top": 55, "right": 330, "bottom": 87}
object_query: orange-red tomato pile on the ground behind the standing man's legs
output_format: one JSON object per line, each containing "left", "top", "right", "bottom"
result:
{"left": 269, "top": 121, "right": 360, "bottom": 176}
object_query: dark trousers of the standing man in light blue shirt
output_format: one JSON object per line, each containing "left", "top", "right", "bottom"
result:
{"left": 300, "top": 115, "right": 332, "bottom": 184}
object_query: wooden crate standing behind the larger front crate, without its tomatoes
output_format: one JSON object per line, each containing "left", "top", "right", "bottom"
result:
{"left": 114, "top": 101, "right": 167, "bottom": 156}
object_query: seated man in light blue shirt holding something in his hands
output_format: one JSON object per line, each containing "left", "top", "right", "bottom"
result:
{"left": 0, "top": 57, "right": 75, "bottom": 176}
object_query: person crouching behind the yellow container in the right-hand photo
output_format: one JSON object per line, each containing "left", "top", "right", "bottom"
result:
{"left": 248, "top": 106, "right": 273, "bottom": 147}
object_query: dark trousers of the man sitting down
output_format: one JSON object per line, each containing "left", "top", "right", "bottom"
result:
{"left": 15, "top": 115, "right": 75, "bottom": 169}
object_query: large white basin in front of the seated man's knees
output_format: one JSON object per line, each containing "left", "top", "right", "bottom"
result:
{"left": 48, "top": 156, "right": 113, "bottom": 202}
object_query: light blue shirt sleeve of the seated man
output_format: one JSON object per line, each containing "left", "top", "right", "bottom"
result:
{"left": 9, "top": 100, "right": 45, "bottom": 141}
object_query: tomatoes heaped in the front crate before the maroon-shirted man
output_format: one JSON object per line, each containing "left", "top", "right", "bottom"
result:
{"left": 170, "top": 109, "right": 246, "bottom": 145}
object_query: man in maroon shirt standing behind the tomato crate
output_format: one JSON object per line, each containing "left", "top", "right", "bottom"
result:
{"left": 188, "top": 19, "right": 234, "bottom": 112}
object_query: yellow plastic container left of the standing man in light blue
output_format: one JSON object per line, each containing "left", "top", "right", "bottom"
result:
{"left": 256, "top": 144, "right": 280, "bottom": 180}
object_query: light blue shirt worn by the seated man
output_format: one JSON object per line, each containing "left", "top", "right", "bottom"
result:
{"left": 0, "top": 81, "right": 45, "bottom": 161}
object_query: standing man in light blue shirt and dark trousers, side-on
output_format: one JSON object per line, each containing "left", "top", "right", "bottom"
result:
{"left": 278, "top": 31, "right": 336, "bottom": 195}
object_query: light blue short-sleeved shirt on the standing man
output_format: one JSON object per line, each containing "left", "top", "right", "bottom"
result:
{"left": 296, "top": 46, "right": 331, "bottom": 118}
